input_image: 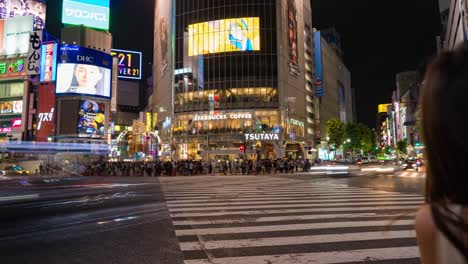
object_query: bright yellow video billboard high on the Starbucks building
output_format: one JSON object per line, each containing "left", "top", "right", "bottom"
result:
{"left": 188, "top": 17, "right": 260, "bottom": 56}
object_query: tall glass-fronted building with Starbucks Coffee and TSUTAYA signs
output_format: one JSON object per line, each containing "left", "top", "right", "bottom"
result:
{"left": 151, "top": 0, "right": 315, "bottom": 159}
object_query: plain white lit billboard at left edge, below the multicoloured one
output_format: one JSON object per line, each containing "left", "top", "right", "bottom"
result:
{"left": 0, "top": 16, "right": 33, "bottom": 55}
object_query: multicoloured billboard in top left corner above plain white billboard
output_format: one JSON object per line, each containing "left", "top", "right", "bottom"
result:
{"left": 0, "top": 0, "right": 46, "bottom": 30}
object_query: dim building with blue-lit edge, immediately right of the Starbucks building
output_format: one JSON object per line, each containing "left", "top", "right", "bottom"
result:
{"left": 314, "top": 30, "right": 354, "bottom": 159}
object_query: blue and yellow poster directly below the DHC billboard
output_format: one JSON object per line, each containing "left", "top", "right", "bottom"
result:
{"left": 78, "top": 100, "right": 106, "bottom": 138}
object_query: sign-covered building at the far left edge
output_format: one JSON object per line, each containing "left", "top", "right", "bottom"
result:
{"left": 0, "top": 1, "right": 46, "bottom": 142}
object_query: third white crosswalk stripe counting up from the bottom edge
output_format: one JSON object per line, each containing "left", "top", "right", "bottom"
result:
{"left": 175, "top": 220, "right": 414, "bottom": 236}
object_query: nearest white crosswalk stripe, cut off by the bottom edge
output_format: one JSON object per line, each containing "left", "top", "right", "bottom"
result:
{"left": 185, "top": 246, "right": 419, "bottom": 264}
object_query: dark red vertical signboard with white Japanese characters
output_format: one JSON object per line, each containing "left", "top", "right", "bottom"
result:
{"left": 36, "top": 84, "right": 56, "bottom": 142}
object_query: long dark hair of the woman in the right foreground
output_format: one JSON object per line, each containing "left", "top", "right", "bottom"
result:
{"left": 421, "top": 42, "right": 468, "bottom": 205}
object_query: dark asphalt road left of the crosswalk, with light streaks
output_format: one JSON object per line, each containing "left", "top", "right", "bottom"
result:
{"left": 0, "top": 177, "right": 183, "bottom": 264}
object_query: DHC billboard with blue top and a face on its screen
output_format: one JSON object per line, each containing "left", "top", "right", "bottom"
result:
{"left": 55, "top": 45, "right": 112, "bottom": 98}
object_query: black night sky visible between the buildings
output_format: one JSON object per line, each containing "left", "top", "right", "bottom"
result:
{"left": 47, "top": 0, "right": 440, "bottom": 127}
